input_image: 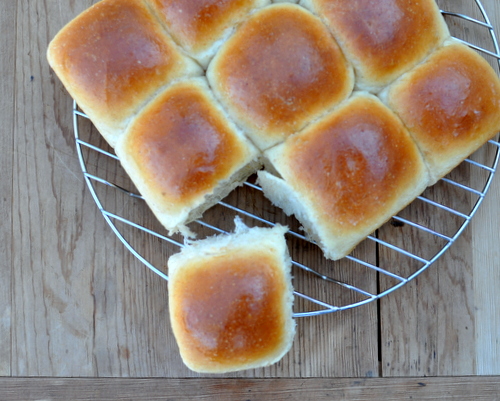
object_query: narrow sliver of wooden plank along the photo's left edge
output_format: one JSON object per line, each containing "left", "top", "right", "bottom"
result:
{"left": 0, "top": 2, "right": 17, "bottom": 376}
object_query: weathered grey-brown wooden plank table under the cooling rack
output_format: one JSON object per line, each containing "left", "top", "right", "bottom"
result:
{"left": 0, "top": 0, "right": 500, "bottom": 400}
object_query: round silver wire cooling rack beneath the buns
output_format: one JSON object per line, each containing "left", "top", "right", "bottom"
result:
{"left": 73, "top": 0, "right": 500, "bottom": 317}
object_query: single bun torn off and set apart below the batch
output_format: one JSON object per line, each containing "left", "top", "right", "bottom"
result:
{"left": 168, "top": 217, "right": 295, "bottom": 373}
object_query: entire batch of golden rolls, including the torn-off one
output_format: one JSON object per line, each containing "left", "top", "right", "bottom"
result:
{"left": 48, "top": 0, "right": 500, "bottom": 373}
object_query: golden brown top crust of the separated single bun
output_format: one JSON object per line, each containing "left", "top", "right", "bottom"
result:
{"left": 171, "top": 250, "right": 286, "bottom": 367}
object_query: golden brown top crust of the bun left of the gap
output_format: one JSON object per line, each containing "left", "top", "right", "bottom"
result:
{"left": 119, "top": 77, "right": 254, "bottom": 210}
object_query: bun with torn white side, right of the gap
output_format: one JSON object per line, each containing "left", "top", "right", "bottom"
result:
{"left": 258, "top": 93, "right": 429, "bottom": 259}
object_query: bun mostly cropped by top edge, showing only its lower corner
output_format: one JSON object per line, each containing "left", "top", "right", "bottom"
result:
{"left": 151, "top": 0, "right": 271, "bottom": 67}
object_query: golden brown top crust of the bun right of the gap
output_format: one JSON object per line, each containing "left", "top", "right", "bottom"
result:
{"left": 286, "top": 97, "right": 422, "bottom": 232}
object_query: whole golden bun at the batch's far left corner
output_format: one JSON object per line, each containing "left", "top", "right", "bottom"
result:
{"left": 48, "top": 0, "right": 203, "bottom": 147}
